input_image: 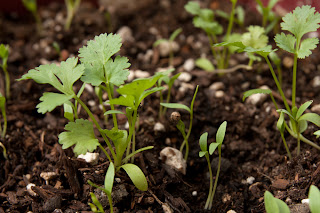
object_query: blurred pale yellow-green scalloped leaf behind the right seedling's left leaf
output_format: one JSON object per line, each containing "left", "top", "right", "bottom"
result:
{"left": 241, "top": 25, "right": 268, "bottom": 49}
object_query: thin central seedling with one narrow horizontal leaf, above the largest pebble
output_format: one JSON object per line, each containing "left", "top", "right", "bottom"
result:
{"left": 160, "top": 85, "right": 199, "bottom": 160}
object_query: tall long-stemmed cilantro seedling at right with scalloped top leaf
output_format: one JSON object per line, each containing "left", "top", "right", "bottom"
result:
{"left": 216, "top": 5, "right": 320, "bottom": 158}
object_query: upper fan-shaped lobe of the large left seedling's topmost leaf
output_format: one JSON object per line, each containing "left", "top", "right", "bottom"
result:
{"left": 79, "top": 33, "right": 121, "bottom": 64}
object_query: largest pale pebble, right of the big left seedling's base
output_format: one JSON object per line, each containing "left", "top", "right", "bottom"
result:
{"left": 160, "top": 147, "right": 187, "bottom": 175}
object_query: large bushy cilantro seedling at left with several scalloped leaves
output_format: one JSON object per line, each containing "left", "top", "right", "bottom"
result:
{"left": 19, "top": 34, "right": 154, "bottom": 211}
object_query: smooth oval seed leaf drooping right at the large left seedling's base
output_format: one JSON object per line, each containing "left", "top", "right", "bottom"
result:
{"left": 120, "top": 163, "right": 148, "bottom": 191}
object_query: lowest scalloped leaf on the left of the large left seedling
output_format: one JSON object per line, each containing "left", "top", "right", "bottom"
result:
{"left": 59, "top": 119, "right": 100, "bottom": 155}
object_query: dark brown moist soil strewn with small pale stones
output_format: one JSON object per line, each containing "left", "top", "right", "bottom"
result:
{"left": 0, "top": 0, "right": 320, "bottom": 213}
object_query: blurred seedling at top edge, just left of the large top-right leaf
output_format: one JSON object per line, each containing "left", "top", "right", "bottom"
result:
{"left": 256, "top": 0, "right": 279, "bottom": 33}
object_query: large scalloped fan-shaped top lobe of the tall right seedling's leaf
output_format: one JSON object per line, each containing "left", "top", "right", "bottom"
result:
{"left": 281, "top": 5, "right": 320, "bottom": 40}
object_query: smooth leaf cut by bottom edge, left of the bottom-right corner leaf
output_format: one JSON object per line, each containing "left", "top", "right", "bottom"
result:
{"left": 264, "top": 191, "right": 290, "bottom": 213}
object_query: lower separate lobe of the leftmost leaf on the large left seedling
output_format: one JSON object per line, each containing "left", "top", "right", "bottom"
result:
{"left": 37, "top": 92, "right": 73, "bottom": 114}
